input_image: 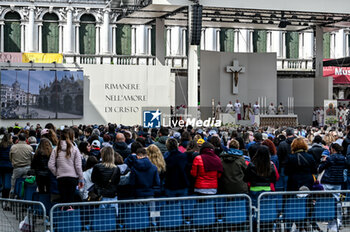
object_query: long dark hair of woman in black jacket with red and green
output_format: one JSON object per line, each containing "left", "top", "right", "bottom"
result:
{"left": 252, "top": 145, "right": 271, "bottom": 177}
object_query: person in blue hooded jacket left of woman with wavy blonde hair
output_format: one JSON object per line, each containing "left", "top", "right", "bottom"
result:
{"left": 130, "top": 148, "right": 160, "bottom": 199}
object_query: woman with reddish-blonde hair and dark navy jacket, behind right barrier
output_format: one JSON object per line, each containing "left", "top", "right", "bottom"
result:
{"left": 286, "top": 138, "right": 317, "bottom": 191}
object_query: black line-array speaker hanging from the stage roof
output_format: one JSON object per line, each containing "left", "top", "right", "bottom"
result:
{"left": 191, "top": 5, "right": 203, "bottom": 45}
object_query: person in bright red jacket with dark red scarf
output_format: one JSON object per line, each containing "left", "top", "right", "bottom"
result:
{"left": 191, "top": 142, "right": 223, "bottom": 195}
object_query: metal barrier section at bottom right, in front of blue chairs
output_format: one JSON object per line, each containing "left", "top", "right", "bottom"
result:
{"left": 257, "top": 190, "right": 350, "bottom": 231}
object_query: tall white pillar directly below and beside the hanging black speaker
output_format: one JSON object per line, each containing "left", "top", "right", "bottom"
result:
{"left": 187, "top": 6, "right": 198, "bottom": 118}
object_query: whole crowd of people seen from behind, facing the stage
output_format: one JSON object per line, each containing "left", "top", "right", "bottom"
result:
{"left": 0, "top": 123, "right": 350, "bottom": 229}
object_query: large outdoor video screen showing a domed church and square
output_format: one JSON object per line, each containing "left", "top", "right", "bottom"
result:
{"left": 0, "top": 70, "right": 84, "bottom": 119}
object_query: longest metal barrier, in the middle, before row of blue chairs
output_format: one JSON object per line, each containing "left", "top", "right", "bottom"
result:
{"left": 50, "top": 194, "right": 252, "bottom": 232}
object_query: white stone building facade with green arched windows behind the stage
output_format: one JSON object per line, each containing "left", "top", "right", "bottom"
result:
{"left": 0, "top": 0, "right": 350, "bottom": 98}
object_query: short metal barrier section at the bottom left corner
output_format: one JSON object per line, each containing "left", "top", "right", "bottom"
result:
{"left": 0, "top": 198, "right": 47, "bottom": 232}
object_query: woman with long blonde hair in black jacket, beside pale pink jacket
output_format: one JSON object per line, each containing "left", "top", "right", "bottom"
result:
{"left": 91, "top": 147, "right": 120, "bottom": 201}
